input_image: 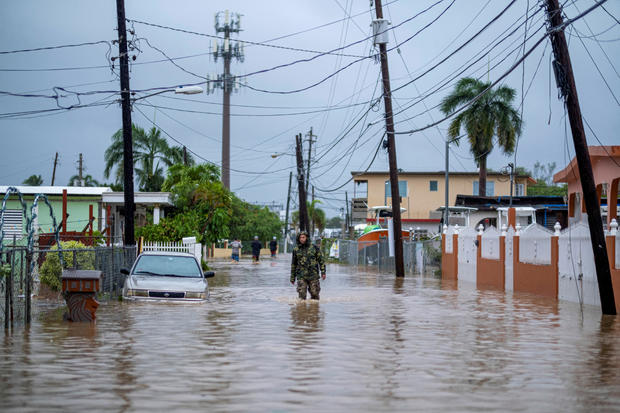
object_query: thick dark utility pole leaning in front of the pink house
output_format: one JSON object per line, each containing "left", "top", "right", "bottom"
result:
{"left": 547, "top": 0, "right": 616, "bottom": 315}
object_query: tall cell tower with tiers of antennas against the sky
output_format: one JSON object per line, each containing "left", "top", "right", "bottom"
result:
{"left": 206, "top": 10, "right": 243, "bottom": 189}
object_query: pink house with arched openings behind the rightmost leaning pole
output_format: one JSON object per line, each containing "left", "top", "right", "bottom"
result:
{"left": 553, "top": 145, "right": 620, "bottom": 228}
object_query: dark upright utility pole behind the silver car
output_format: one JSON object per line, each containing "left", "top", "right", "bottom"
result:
{"left": 116, "top": 0, "right": 136, "bottom": 246}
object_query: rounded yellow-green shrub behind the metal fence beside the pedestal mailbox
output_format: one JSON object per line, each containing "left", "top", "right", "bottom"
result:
{"left": 39, "top": 241, "right": 95, "bottom": 291}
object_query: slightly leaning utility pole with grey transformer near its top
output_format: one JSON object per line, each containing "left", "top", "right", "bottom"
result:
{"left": 372, "top": 0, "right": 405, "bottom": 277}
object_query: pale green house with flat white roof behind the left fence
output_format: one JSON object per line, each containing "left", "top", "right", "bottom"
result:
{"left": 0, "top": 186, "right": 172, "bottom": 242}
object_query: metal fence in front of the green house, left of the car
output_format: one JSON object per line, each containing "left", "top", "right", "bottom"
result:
{"left": 0, "top": 246, "right": 136, "bottom": 328}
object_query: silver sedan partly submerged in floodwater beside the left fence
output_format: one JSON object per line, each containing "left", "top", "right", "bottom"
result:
{"left": 121, "top": 251, "right": 215, "bottom": 302}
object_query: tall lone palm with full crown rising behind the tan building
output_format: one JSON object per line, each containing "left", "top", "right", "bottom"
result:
{"left": 441, "top": 77, "right": 522, "bottom": 196}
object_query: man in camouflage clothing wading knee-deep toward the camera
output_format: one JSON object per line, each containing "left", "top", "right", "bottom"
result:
{"left": 291, "top": 231, "right": 325, "bottom": 300}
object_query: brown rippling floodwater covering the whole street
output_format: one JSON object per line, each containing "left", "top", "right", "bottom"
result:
{"left": 0, "top": 256, "right": 620, "bottom": 412}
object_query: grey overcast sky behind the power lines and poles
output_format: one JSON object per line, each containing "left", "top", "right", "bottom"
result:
{"left": 0, "top": 0, "right": 620, "bottom": 216}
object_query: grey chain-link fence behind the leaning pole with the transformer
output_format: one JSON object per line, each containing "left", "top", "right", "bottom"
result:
{"left": 338, "top": 240, "right": 441, "bottom": 274}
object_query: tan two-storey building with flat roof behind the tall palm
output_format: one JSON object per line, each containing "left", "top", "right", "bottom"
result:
{"left": 351, "top": 171, "right": 535, "bottom": 232}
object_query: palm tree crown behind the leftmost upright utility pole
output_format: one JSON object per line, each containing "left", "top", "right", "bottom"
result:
{"left": 103, "top": 125, "right": 194, "bottom": 192}
